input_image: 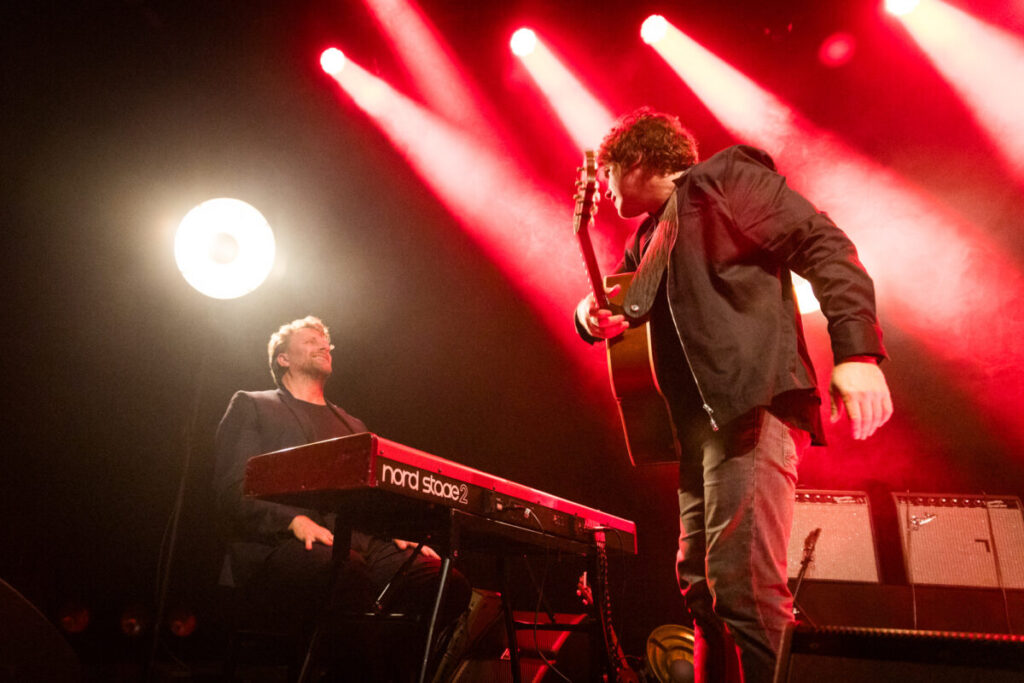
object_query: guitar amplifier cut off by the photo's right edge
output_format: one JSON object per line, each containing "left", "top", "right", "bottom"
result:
{"left": 893, "top": 493, "right": 1024, "bottom": 589}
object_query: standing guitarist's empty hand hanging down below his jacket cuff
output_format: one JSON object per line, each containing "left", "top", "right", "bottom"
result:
{"left": 829, "top": 360, "right": 893, "bottom": 439}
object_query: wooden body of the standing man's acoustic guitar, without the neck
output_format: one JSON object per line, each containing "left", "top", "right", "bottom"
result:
{"left": 605, "top": 272, "right": 679, "bottom": 465}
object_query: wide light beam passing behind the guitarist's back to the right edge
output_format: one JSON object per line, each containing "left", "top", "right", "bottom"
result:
{"left": 654, "top": 17, "right": 1024, "bottom": 444}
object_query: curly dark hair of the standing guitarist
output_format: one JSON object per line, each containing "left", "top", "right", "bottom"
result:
{"left": 597, "top": 106, "right": 697, "bottom": 173}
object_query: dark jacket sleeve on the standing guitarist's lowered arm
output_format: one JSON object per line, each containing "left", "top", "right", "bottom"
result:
{"left": 721, "top": 146, "right": 887, "bottom": 362}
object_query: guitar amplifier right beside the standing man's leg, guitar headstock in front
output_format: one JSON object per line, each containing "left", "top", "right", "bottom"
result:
{"left": 786, "top": 488, "right": 879, "bottom": 584}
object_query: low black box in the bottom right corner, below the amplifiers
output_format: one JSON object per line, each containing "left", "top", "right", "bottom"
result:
{"left": 775, "top": 626, "right": 1024, "bottom": 683}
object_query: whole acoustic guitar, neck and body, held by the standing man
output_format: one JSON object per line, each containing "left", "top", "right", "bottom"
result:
{"left": 572, "top": 150, "right": 679, "bottom": 465}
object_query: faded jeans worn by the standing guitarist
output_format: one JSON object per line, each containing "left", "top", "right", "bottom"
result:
{"left": 676, "top": 409, "right": 810, "bottom": 683}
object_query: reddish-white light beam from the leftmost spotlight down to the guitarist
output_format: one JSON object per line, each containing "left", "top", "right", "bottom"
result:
{"left": 325, "top": 57, "right": 606, "bottom": 348}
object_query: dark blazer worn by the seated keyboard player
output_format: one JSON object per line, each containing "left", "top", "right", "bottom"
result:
{"left": 214, "top": 389, "right": 368, "bottom": 586}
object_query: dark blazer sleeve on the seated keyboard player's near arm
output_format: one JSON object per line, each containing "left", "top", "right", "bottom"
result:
{"left": 214, "top": 391, "right": 319, "bottom": 543}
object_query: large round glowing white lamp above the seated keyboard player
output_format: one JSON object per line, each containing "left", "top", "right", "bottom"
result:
{"left": 174, "top": 199, "right": 274, "bottom": 299}
